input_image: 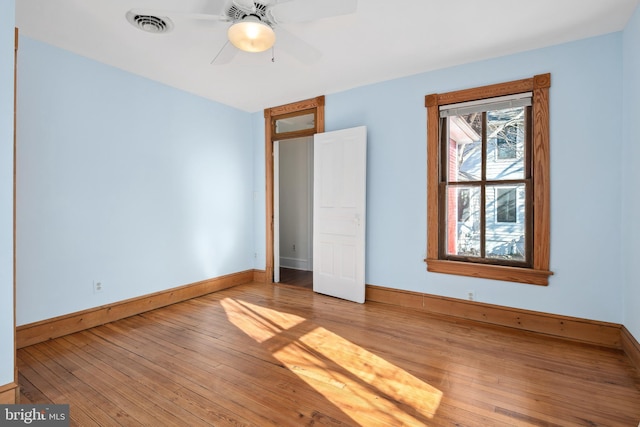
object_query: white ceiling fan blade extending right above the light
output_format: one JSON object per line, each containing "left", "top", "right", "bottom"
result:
{"left": 269, "top": 0, "right": 358, "bottom": 24}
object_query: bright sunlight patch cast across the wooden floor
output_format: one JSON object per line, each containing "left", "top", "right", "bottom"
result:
{"left": 221, "top": 298, "right": 442, "bottom": 425}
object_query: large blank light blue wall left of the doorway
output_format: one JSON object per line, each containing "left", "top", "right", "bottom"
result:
{"left": 17, "top": 37, "right": 255, "bottom": 325}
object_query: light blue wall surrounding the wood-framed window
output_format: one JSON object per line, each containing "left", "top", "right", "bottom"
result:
{"left": 326, "top": 33, "right": 623, "bottom": 323}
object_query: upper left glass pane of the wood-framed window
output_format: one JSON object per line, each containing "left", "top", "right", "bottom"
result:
{"left": 447, "top": 113, "right": 482, "bottom": 182}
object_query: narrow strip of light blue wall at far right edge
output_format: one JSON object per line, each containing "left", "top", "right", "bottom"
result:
{"left": 622, "top": 7, "right": 640, "bottom": 341}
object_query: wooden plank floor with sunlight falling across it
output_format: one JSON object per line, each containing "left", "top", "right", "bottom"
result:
{"left": 18, "top": 284, "right": 640, "bottom": 427}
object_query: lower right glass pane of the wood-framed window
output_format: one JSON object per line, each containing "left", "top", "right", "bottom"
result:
{"left": 485, "top": 184, "right": 526, "bottom": 261}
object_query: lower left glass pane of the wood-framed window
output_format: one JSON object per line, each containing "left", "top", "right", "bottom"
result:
{"left": 445, "top": 186, "right": 480, "bottom": 257}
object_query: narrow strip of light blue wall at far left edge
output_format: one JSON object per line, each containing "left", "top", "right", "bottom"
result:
{"left": 0, "top": 0, "right": 15, "bottom": 386}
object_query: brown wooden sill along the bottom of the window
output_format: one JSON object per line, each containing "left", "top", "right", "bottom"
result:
{"left": 425, "top": 259, "right": 553, "bottom": 286}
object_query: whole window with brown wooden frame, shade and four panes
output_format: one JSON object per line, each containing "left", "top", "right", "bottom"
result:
{"left": 425, "top": 74, "right": 552, "bottom": 285}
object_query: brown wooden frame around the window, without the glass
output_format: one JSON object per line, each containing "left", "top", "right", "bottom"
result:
{"left": 425, "top": 74, "right": 553, "bottom": 286}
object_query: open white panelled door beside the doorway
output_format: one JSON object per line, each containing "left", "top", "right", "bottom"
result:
{"left": 313, "top": 126, "right": 367, "bottom": 303}
